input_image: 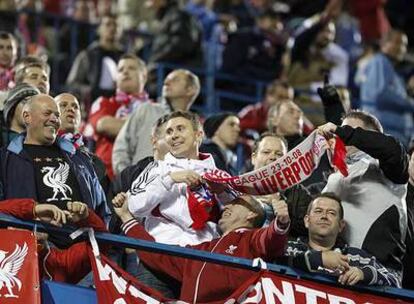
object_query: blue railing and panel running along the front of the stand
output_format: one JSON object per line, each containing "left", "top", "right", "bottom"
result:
{"left": 0, "top": 214, "right": 414, "bottom": 304}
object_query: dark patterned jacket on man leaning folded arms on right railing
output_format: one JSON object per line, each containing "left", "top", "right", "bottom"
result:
{"left": 285, "top": 239, "right": 401, "bottom": 287}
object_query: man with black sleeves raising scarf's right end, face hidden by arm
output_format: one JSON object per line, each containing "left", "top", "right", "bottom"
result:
{"left": 318, "top": 111, "right": 408, "bottom": 286}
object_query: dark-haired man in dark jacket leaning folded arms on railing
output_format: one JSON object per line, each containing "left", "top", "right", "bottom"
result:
{"left": 285, "top": 192, "right": 401, "bottom": 287}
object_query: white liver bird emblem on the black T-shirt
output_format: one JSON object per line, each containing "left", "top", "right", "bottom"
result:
{"left": 41, "top": 163, "right": 72, "bottom": 202}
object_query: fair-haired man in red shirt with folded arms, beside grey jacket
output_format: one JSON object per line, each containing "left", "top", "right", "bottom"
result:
{"left": 84, "top": 54, "right": 149, "bottom": 178}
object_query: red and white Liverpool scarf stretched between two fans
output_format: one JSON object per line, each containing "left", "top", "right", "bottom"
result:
{"left": 203, "top": 131, "right": 348, "bottom": 195}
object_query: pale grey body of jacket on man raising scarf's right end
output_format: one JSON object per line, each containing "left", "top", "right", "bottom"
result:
{"left": 323, "top": 151, "right": 407, "bottom": 263}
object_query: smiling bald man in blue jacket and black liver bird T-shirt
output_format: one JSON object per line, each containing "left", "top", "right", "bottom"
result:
{"left": 0, "top": 94, "right": 109, "bottom": 226}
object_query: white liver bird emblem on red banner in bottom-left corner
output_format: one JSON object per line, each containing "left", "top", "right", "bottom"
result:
{"left": 0, "top": 243, "right": 28, "bottom": 298}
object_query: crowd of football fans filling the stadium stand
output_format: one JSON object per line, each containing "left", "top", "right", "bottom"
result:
{"left": 0, "top": 0, "right": 414, "bottom": 302}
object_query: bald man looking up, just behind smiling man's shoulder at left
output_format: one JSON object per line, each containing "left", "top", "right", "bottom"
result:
{"left": 55, "top": 93, "right": 110, "bottom": 193}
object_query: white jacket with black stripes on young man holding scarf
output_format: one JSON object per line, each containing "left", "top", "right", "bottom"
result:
{"left": 128, "top": 153, "right": 235, "bottom": 246}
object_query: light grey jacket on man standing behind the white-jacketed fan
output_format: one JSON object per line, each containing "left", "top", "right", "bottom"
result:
{"left": 112, "top": 102, "right": 171, "bottom": 174}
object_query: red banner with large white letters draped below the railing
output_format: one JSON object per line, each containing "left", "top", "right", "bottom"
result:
{"left": 89, "top": 250, "right": 408, "bottom": 304}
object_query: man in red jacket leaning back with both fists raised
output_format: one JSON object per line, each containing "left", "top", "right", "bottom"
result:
{"left": 112, "top": 193, "right": 290, "bottom": 303}
